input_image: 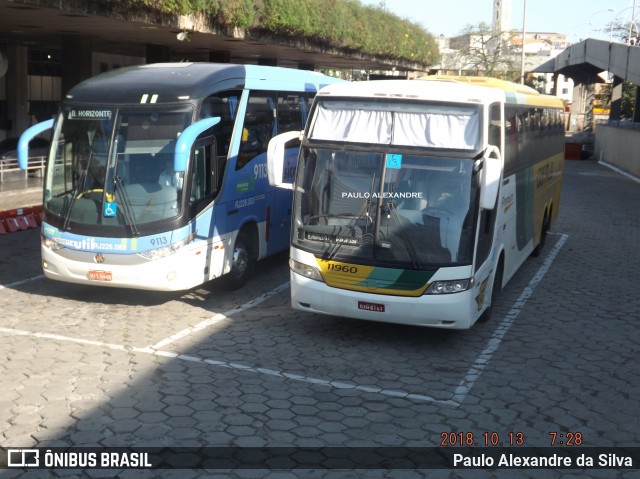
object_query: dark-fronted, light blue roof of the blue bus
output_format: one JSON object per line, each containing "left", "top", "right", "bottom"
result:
{"left": 67, "top": 62, "right": 342, "bottom": 104}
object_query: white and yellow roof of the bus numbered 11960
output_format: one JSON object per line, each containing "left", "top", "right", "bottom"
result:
{"left": 319, "top": 77, "right": 563, "bottom": 108}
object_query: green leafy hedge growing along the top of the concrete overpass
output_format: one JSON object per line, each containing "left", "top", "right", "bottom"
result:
{"left": 111, "top": 0, "right": 439, "bottom": 65}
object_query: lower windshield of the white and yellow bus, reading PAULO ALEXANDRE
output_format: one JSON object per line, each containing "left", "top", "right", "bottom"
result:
{"left": 293, "top": 144, "right": 478, "bottom": 269}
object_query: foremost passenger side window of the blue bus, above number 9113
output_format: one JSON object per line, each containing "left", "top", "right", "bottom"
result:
{"left": 236, "top": 92, "right": 276, "bottom": 170}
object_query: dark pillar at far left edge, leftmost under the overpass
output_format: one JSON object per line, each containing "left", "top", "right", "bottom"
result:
{"left": 5, "top": 45, "right": 31, "bottom": 136}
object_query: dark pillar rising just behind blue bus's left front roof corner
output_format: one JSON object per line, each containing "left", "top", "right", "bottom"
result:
{"left": 60, "top": 35, "right": 93, "bottom": 98}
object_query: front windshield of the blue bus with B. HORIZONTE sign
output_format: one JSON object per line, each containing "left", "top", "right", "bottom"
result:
{"left": 44, "top": 106, "right": 193, "bottom": 231}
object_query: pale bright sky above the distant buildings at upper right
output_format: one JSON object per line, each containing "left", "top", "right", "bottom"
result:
{"left": 360, "top": 0, "right": 640, "bottom": 42}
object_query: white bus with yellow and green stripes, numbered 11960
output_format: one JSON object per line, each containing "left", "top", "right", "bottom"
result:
{"left": 268, "top": 77, "right": 564, "bottom": 329}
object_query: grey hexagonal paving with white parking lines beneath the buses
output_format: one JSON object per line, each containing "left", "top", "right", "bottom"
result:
{"left": 0, "top": 161, "right": 640, "bottom": 479}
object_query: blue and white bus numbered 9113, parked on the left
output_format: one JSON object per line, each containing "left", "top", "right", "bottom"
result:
{"left": 19, "top": 63, "right": 339, "bottom": 291}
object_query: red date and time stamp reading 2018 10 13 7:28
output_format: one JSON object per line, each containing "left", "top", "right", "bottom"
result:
{"left": 440, "top": 431, "right": 582, "bottom": 447}
